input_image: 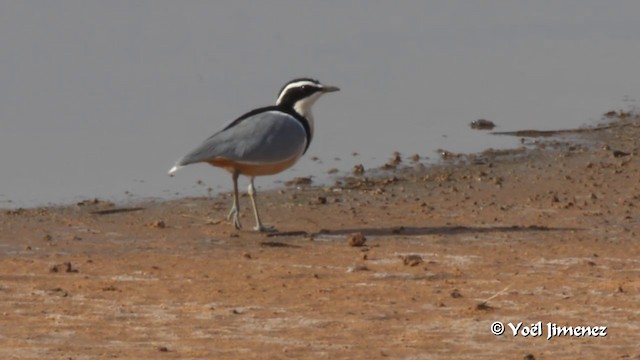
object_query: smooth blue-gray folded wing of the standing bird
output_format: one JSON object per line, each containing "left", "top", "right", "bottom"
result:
{"left": 177, "top": 110, "right": 307, "bottom": 166}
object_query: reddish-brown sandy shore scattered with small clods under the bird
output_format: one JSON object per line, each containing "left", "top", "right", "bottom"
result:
{"left": 0, "top": 116, "right": 640, "bottom": 359}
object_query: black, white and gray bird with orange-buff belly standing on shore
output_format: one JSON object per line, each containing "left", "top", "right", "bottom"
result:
{"left": 169, "top": 78, "right": 340, "bottom": 232}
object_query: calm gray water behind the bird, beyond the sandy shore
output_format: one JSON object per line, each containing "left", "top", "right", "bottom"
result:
{"left": 0, "top": 0, "right": 640, "bottom": 207}
